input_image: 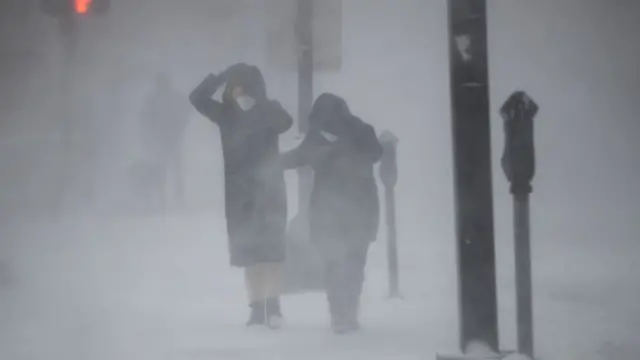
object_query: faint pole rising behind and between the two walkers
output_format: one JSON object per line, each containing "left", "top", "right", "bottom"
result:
{"left": 296, "top": 0, "right": 313, "bottom": 224}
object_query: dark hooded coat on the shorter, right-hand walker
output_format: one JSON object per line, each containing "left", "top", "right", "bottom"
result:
{"left": 282, "top": 94, "right": 382, "bottom": 242}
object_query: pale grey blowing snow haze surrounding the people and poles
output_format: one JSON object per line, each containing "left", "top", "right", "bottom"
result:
{"left": 0, "top": 0, "right": 640, "bottom": 360}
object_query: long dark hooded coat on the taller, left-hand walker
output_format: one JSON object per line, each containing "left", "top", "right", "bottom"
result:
{"left": 189, "top": 64, "right": 293, "bottom": 267}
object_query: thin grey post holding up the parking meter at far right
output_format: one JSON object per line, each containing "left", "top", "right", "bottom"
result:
{"left": 513, "top": 194, "right": 533, "bottom": 358}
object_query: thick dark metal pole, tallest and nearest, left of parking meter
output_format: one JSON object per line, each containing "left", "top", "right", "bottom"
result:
{"left": 448, "top": 0, "right": 499, "bottom": 352}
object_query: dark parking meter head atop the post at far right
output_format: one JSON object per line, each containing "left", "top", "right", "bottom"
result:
{"left": 500, "top": 91, "right": 538, "bottom": 197}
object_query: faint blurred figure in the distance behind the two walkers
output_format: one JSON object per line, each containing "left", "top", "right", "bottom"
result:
{"left": 135, "top": 72, "right": 190, "bottom": 210}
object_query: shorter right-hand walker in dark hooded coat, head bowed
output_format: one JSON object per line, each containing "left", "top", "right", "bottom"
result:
{"left": 282, "top": 93, "right": 382, "bottom": 333}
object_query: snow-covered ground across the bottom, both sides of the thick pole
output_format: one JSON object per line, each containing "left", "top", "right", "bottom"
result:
{"left": 0, "top": 216, "right": 640, "bottom": 360}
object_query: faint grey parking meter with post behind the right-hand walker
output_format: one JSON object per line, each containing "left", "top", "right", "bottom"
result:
{"left": 379, "top": 130, "right": 401, "bottom": 298}
